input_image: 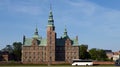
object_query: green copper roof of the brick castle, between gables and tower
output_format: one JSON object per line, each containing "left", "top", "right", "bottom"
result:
{"left": 23, "top": 38, "right": 79, "bottom": 46}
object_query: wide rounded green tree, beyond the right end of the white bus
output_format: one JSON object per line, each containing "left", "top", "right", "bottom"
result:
{"left": 89, "top": 48, "right": 107, "bottom": 61}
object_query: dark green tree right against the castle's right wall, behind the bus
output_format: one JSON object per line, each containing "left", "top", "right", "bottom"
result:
{"left": 79, "top": 44, "right": 90, "bottom": 59}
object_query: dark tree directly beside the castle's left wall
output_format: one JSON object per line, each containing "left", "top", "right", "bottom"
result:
{"left": 13, "top": 42, "right": 22, "bottom": 61}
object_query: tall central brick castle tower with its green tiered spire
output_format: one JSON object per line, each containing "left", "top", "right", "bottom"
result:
{"left": 46, "top": 9, "right": 56, "bottom": 64}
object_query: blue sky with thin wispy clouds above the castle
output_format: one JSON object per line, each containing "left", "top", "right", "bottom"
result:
{"left": 0, "top": 0, "right": 120, "bottom": 51}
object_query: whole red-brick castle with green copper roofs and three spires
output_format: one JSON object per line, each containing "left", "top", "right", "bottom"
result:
{"left": 21, "top": 9, "right": 79, "bottom": 64}
